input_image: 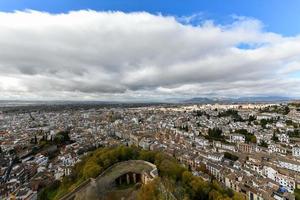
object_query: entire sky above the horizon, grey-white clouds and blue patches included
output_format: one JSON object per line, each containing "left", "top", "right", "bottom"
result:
{"left": 0, "top": 0, "right": 300, "bottom": 101}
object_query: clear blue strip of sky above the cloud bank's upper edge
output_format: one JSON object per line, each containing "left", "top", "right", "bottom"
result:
{"left": 0, "top": 0, "right": 300, "bottom": 36}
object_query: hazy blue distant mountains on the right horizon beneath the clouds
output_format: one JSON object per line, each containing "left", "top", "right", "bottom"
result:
{"left": 179, "top": 96, "right": 296, "bottom": 103}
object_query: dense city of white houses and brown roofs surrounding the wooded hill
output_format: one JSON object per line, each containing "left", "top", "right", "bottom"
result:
{"left": 0, "top": 102, "right": 300, "bottom": 199}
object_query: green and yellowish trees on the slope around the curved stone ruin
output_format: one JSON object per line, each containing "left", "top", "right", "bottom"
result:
{"left": 38, "top": 146, "right": 243, "bottom": 200}
